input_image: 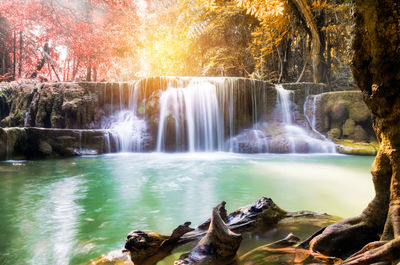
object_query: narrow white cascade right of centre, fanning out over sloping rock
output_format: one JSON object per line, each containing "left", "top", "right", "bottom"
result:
{"left": 275, "top": 84, "right": 336, "bottom": 153}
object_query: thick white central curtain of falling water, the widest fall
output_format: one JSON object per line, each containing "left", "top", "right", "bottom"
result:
{"left": 156, "top": 78, "right": 238, "bottom": 152}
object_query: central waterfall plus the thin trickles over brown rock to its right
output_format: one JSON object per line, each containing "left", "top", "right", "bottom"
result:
{"left": 156, "top": 78, "right": 267, "bottom": 152}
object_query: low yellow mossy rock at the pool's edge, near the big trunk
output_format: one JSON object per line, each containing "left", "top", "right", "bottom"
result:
{"left": 335, "top": 140, "right": 379, "bottom": 156}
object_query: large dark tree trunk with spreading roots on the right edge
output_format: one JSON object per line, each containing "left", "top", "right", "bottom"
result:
{"left": 311, "top": 0, "right": 400, "bottom": 264}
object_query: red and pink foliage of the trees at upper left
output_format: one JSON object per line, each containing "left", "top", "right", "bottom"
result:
{"left": 0, "top": 0, "right": 138, "bottom": 80}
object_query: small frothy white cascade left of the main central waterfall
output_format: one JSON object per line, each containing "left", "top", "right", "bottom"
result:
{"left": 102, "top": 83, "right": 147, "bottom": 152}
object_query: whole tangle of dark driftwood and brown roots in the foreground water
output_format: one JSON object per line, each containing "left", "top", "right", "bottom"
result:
{"left": 123, "top": 197, "right": 337, "bottom": 265}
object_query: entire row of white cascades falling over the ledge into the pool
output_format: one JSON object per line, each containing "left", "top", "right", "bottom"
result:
{"left": 102, "top": 77, "right": 335, "bottom": 153}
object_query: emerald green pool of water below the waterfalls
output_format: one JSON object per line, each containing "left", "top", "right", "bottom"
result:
{"left": 0, "top": 153, "right": 373, "bottom": 265}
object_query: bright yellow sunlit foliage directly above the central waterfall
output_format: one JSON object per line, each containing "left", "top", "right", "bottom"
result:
{"left": 138, "top": 0, "right": 257, "bottom": 76}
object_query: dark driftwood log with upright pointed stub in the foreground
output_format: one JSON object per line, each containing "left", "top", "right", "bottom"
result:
{"left": 123, "top": 197, "right": 287, "bottom": 265}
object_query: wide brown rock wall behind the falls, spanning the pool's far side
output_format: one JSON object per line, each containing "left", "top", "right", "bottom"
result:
{"left": 0, "top": 77, "right": 375, "bottom": 159}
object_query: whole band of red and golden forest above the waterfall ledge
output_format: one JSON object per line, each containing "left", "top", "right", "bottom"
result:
{"left": 0, "top": 0, "right": 352, "bottom": 84}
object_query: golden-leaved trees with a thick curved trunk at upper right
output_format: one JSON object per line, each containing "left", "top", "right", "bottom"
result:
{"left": 236, "top": 0, "right": 350, "bottom": 83}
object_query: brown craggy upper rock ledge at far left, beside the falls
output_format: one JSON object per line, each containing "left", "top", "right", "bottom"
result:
{"left": 0, "top": 83, "right": 99, "bottom": 128}
